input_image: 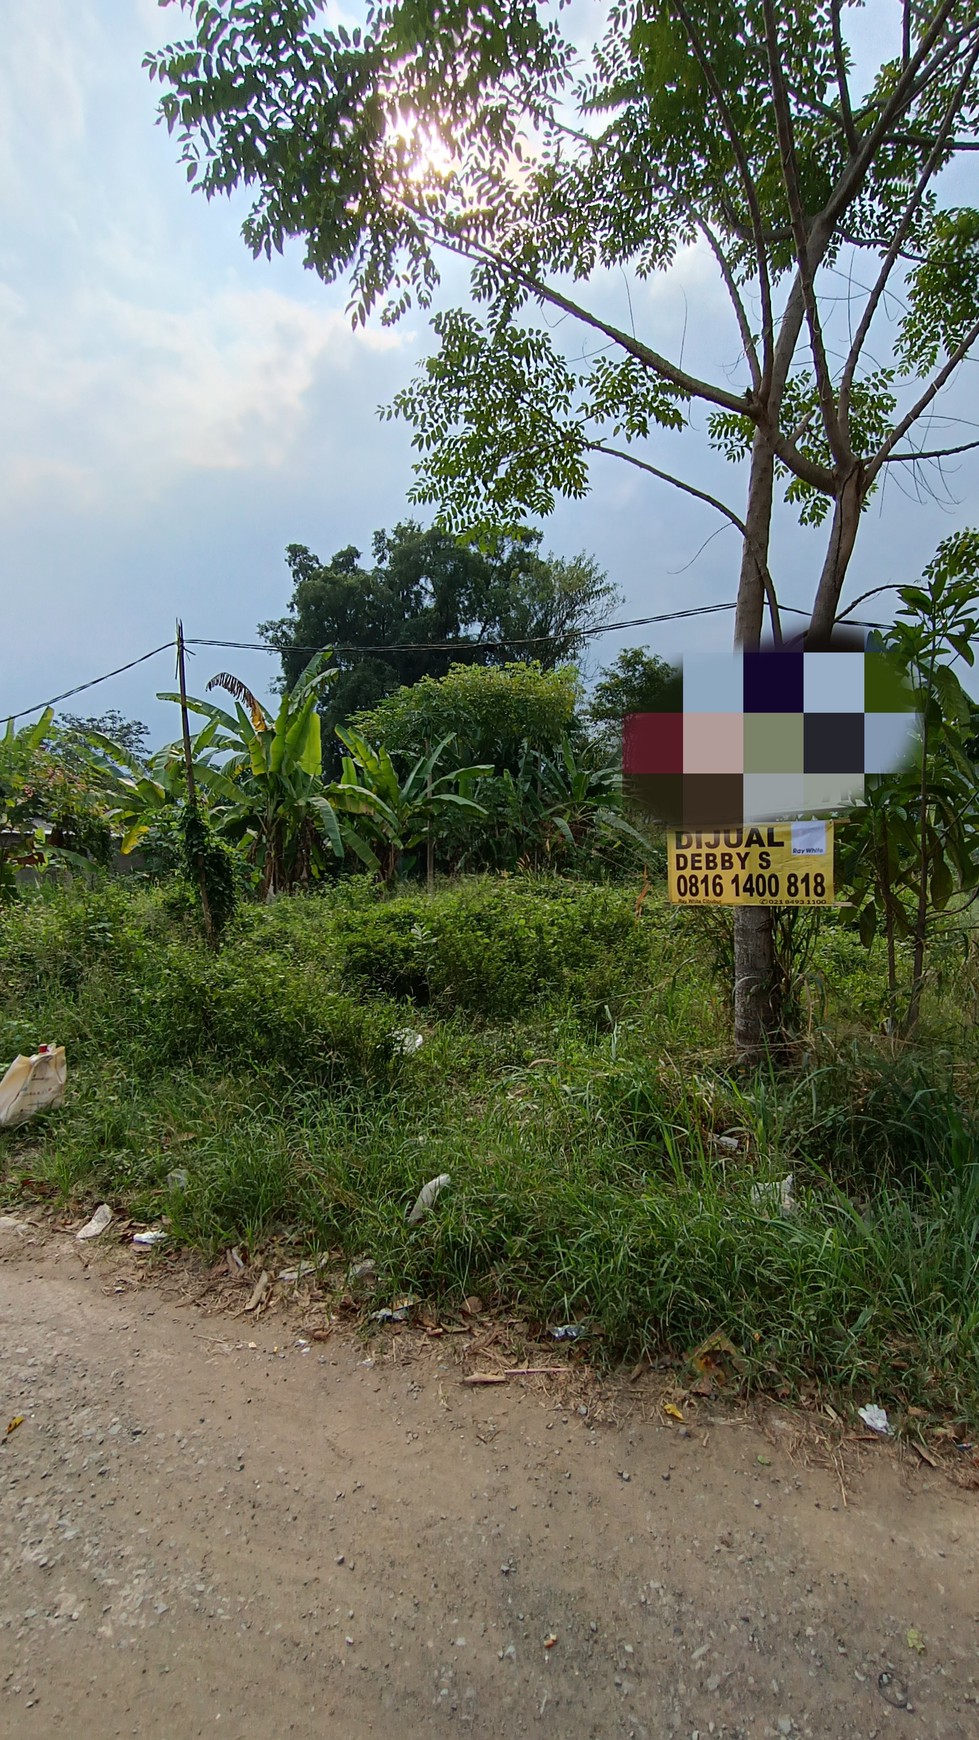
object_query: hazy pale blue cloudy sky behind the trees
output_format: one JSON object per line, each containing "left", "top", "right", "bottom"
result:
{"left": 0, "top": 0, "right": 979, "bottom": 741}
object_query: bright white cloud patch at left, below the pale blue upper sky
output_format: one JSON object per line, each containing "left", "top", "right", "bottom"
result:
{"left": 0, "top": 285, "right": 407, "bottom": 510}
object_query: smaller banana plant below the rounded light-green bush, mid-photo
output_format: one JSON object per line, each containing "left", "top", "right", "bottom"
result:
{"left": 329, "top": 726, "right": 492, "bottom": 887}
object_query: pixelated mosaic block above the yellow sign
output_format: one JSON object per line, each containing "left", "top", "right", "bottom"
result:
{"left": 623, "top": 647, "right": 920, "bottom": 830}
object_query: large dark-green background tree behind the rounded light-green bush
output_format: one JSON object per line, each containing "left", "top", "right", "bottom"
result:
{"left": 259, "top": 520, "right": 617, "bottom": 767}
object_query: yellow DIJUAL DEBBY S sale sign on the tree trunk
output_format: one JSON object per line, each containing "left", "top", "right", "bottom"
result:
{"left": 668, "top": 821, "right": 833, "bottom": 907}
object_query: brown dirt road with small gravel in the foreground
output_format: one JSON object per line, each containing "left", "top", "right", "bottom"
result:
{"left": 0, "top": 1241, "right": 979, "bottom": 1740}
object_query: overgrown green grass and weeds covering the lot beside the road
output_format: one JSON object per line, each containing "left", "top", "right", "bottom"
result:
{"left": 0, "top": 879, "right": 979, "bottom": 1422}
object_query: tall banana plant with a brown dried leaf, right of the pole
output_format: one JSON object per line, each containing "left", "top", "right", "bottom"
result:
{"left": 160, "top": 647, "right": 348, "bottom": 898}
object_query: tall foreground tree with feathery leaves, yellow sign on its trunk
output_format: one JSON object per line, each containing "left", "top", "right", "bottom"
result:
{"left": 148, "top": 0, "right": 979, "bottom": 1053}
